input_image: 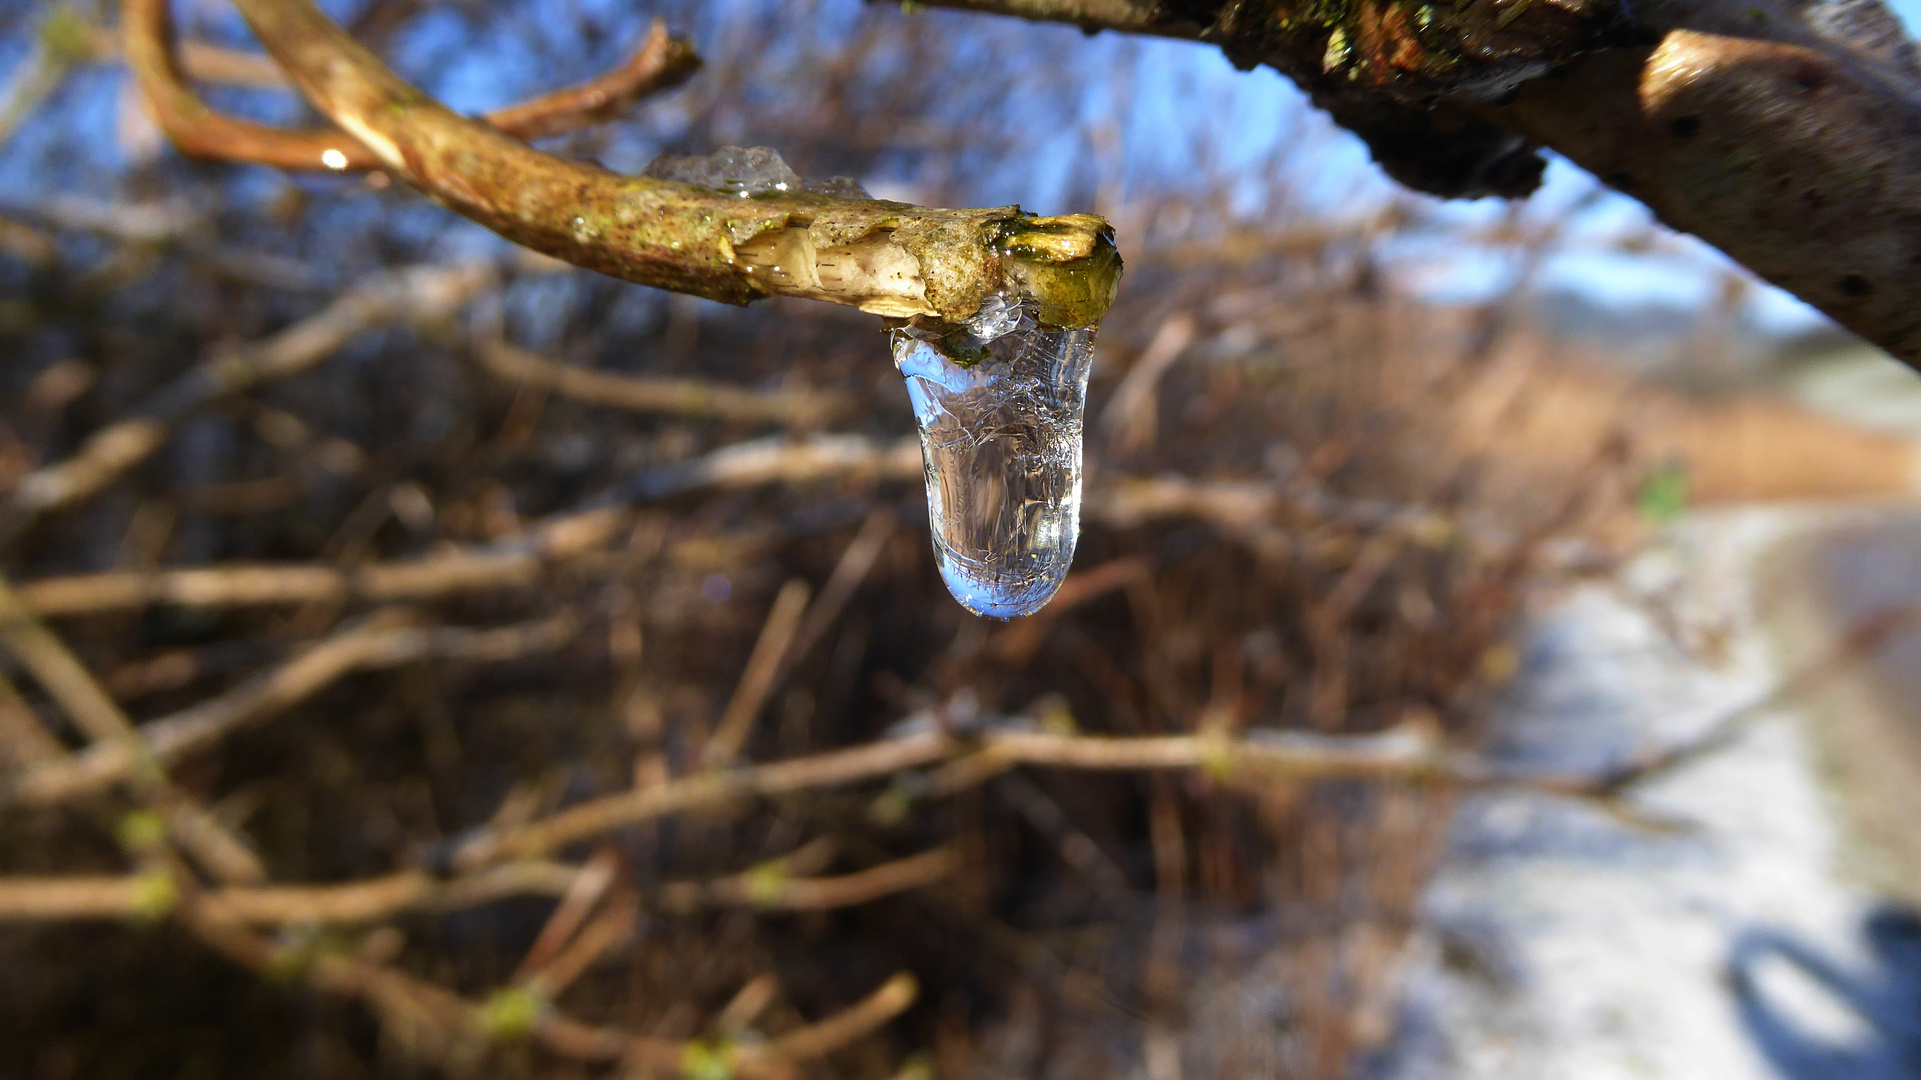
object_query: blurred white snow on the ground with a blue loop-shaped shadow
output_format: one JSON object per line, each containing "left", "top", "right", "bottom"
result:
{"left": 1370, "top": 509, "right": 1921, "bottom": 1080}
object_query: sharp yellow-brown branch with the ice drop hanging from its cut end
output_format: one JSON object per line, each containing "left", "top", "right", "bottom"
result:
{"left": 180, "top": 0, "right": 1120, "bottom": 327}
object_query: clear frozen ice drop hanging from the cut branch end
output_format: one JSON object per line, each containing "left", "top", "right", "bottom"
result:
{"left": 893, "top": 298, "right": 1095, "bottom": 619}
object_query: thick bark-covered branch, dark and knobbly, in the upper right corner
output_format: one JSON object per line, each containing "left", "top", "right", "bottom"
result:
{"left": 906, "top": 0, "right": 1921, "bottom": 365}
